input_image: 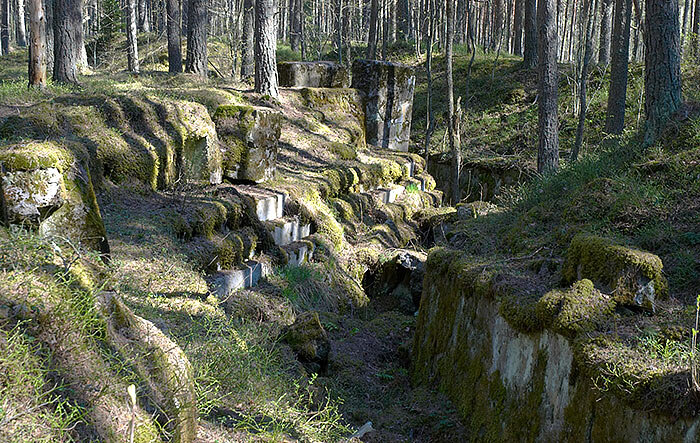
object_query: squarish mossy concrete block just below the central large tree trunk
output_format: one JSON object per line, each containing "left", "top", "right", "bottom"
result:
{"left": 214, "top": 105, "right": 282, "bottom": 182}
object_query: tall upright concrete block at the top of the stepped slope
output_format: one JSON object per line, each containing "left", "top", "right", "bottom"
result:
{"left": 352, "top": 60, "right": 416, "bottom": 152}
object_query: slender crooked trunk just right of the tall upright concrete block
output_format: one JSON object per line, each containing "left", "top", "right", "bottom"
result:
{"left": 445, "top": 0, "right": 462, "bottom": 205}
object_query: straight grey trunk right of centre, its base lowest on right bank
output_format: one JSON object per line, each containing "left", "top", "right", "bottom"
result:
{"left": 537, "top": 0, "right": 559, "bottom": 173}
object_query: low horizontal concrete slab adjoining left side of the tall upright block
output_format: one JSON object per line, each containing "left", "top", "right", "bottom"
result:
{"left": 277, "top": 61, "right": 350, "bottom": 88}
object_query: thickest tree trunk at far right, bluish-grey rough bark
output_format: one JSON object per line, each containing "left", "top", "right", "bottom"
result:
{"left": 644, "top": 0, "right": 681, "bottom": 144}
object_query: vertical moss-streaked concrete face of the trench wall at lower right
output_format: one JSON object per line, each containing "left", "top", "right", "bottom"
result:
{"left": 413, "top": 260, "right": 700, "bottom": 442}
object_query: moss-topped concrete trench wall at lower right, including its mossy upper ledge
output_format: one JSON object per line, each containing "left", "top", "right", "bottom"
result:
{"left": 412, "top": 248, "right": 700, "bottom": 441}
